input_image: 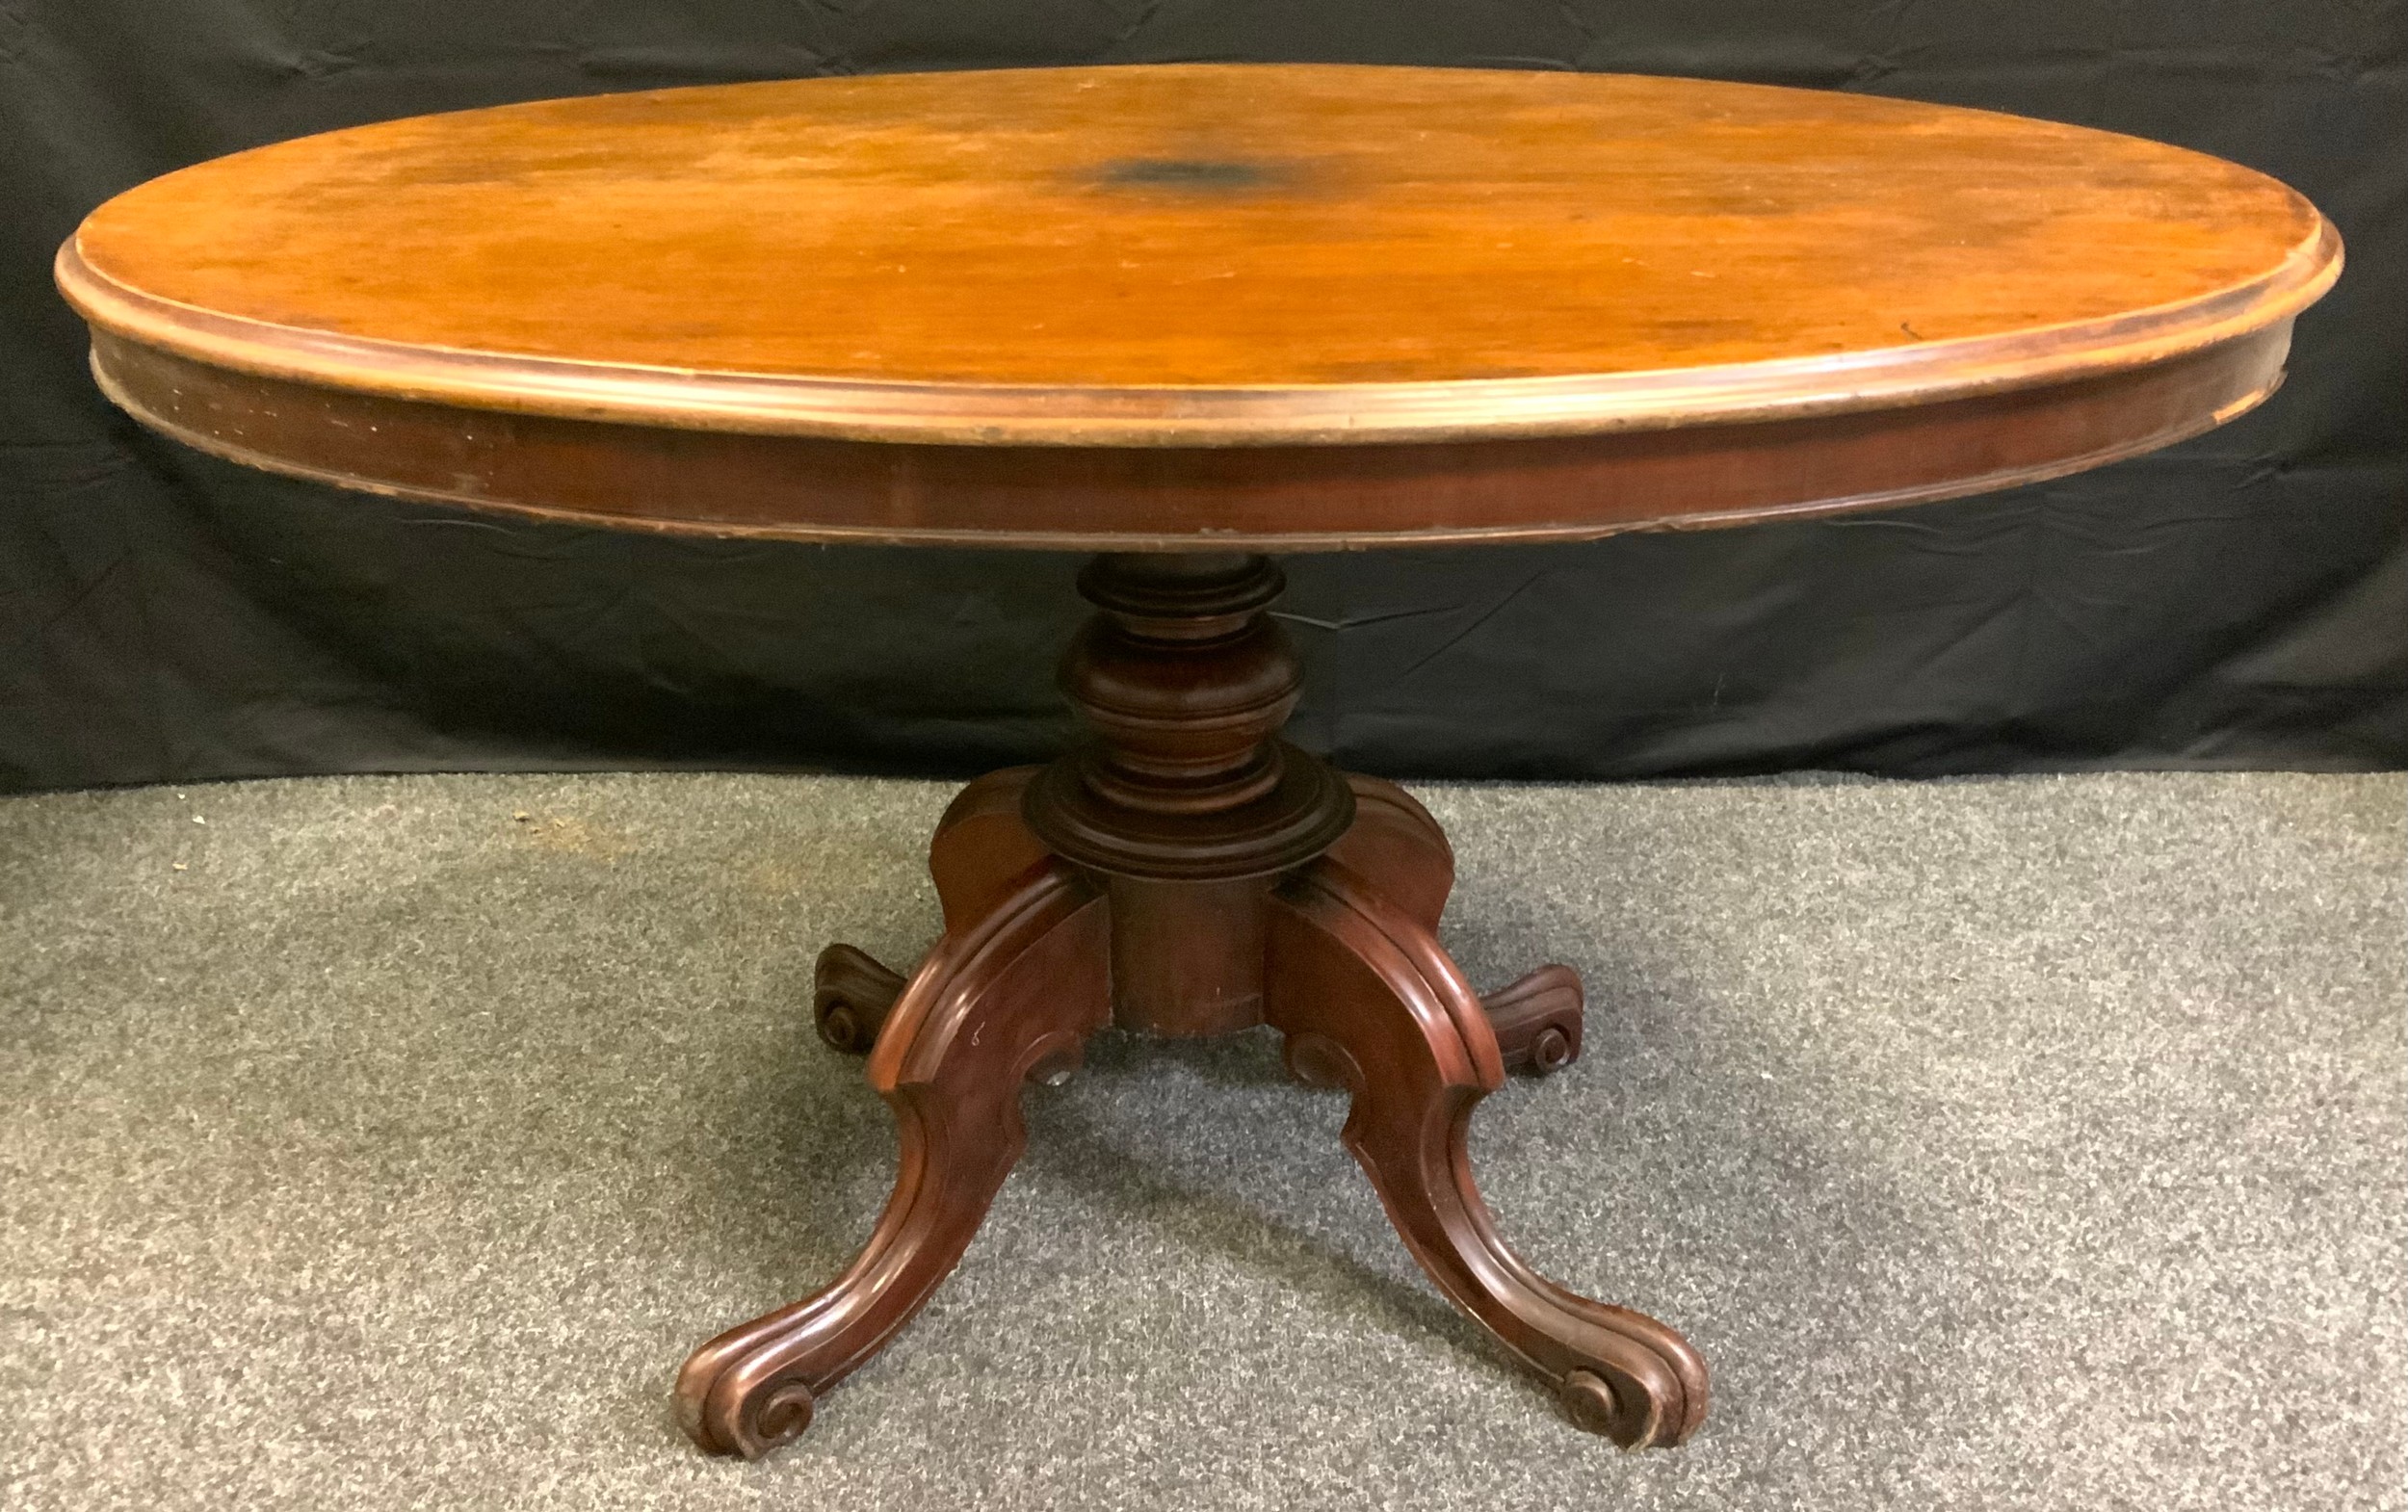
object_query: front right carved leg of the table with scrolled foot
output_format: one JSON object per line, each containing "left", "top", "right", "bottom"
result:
{"left": 1267, "top": 855, "right": 1708, "bottom": 1449}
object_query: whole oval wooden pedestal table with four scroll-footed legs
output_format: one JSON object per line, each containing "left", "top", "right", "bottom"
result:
{"left": 58, "top": 65, "right": 2341, "bottom": 1457}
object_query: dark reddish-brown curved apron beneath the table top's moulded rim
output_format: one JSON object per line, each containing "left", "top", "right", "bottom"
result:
{"left": 80, "top": 323, "right": 2290, "bottom": 552}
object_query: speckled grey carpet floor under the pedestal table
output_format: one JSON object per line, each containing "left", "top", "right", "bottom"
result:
{"left": 0, "top": 775, "right": 2408, "bottom": 1512}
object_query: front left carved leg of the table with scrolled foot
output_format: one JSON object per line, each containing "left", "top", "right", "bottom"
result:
{"left": 677, "top": 773, "right": 1112, "bottom": 1459}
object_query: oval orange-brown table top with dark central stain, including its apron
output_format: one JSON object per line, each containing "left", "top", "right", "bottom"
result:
{"left": 58, "top": 65, "right": 2341, "bottom": 544}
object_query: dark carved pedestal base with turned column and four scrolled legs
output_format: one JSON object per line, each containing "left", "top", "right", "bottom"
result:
{"left": 677, "top": 557, "right": 1708, "bottom": 1457}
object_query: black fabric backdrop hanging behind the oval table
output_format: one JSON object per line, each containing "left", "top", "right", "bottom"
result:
{"left": 0, "top": 0, "right": 2408, "bottom": 788}
